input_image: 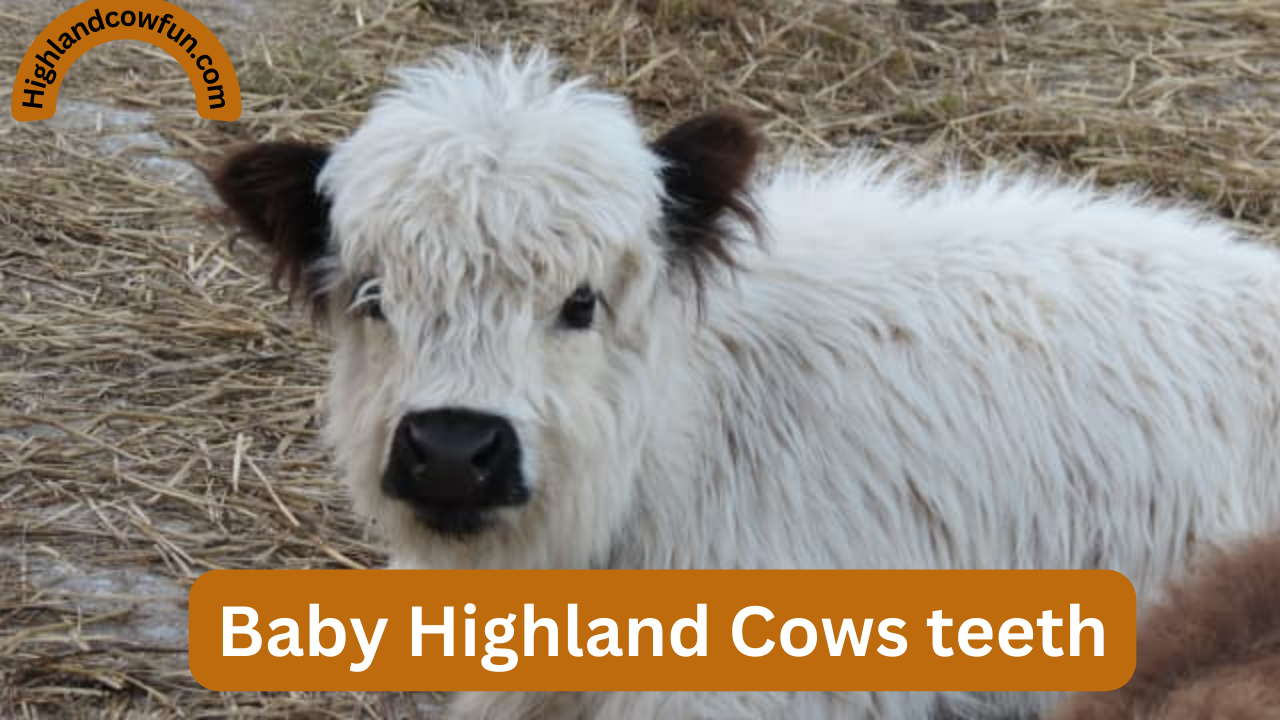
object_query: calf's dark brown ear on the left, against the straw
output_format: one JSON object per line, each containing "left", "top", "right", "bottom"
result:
{"left": 210, "top": 142, "right": 329, "bottom": 307}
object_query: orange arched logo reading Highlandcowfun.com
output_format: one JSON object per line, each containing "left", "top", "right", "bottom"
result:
{"left": 10, "top": 0, "right": 241, "bottom": 123}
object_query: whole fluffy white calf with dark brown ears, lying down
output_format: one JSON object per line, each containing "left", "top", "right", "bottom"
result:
{"left": 214, "top": 51, "right": 1280, "bottom": 720}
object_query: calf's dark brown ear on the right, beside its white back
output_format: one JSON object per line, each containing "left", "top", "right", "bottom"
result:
{"left": 653, "top": 110, "right": 764, "bottom": 286}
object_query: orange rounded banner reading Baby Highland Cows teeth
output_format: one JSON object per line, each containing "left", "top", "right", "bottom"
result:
{"left": 189, "top": 570, "right": 1137, "bottom": 691}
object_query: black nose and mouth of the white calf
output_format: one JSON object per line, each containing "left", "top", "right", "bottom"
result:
{"left": 383, "top": 407, "right": 529, "bottom": 534}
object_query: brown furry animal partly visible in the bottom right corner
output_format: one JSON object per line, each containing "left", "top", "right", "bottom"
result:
{"left": 1053, "top": 534, "right": 1280, "bottom": 720}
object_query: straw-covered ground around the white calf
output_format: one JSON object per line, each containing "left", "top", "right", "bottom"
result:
{"left": 0, "top": 0, "right": 1280, "bottom": 717}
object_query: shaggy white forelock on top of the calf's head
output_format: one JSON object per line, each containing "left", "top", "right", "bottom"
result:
{"left": 320, "top": 50, "right": 662, "bottom": 322}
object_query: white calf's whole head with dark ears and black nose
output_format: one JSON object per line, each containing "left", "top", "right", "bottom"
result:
{"left": 212, "top": 51, "right": 759, "bottom": 566}
